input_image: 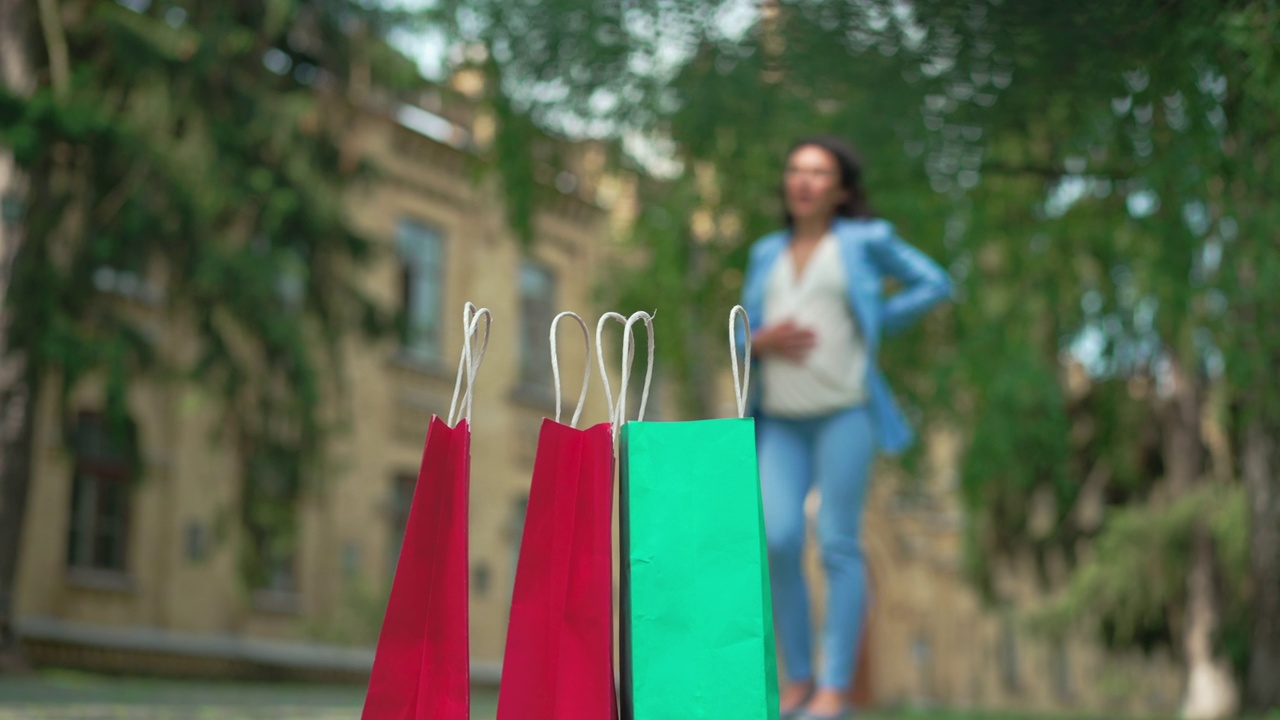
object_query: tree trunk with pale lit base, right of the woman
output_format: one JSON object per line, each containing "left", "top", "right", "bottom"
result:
{"left": 1164, "top": 361, "right": 1239, "bottom": 720}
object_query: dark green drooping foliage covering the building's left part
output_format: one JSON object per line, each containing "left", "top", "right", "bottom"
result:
{"left": 0, "top": 0, "right": 419, "bottom": 583}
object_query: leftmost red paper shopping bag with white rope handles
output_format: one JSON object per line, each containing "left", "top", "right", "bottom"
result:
{"left": 361, "top": 302, "right": 492, "bottom": 720}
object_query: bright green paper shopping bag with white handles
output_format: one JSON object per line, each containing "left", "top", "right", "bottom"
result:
{"left": 620, "top": 307, "right": 778, "bottom": 720}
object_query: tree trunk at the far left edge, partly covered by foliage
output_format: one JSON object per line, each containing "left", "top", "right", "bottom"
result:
{"left": 0, "top": 0, "right": 36, "bottom": 674}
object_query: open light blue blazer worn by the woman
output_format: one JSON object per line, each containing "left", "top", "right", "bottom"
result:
{"left": 739, "top": 218, "right": 951, "bottom": 454}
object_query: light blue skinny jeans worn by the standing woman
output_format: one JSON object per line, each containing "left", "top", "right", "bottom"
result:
{"left": 758, "top": 406, "right": 876, "bottom": 691}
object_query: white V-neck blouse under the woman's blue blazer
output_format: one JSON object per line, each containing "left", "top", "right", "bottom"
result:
{"left": 760, "top": 233, "right": 867, "bottom": 418}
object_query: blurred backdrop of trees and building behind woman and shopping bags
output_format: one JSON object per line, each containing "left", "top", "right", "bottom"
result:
{"left": 0, "top": 0, "right": 1280, "bottom": 719}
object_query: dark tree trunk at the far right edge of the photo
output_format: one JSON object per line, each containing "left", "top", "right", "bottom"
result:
{"left": 1242, "top": 419, "right": 1280, "bottom": 711}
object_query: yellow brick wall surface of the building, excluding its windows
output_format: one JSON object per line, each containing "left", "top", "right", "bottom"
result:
{"left": 18, "top": 103, "right": 619, "bottom": 664}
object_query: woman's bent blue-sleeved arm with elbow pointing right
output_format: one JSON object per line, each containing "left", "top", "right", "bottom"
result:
{"left": 870, "top": 223, "right": 951, "bottom": 333}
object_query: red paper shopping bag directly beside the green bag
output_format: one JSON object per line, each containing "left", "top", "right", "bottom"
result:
{"left": 498, "top": 313, "right": 618, "bottom": 720}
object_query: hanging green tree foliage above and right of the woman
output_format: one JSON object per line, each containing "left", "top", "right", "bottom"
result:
{"left": 439, "top": 0, "right": 1280, "bottom": 681}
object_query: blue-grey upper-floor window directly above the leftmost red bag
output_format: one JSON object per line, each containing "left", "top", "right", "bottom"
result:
{"left": 396, "top": 220, "right": 444, "bottom": 363}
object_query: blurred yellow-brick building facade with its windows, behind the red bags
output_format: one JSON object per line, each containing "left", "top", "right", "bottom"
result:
{"left": 17, "top": 95, "right": 619, "bottom": 674}
